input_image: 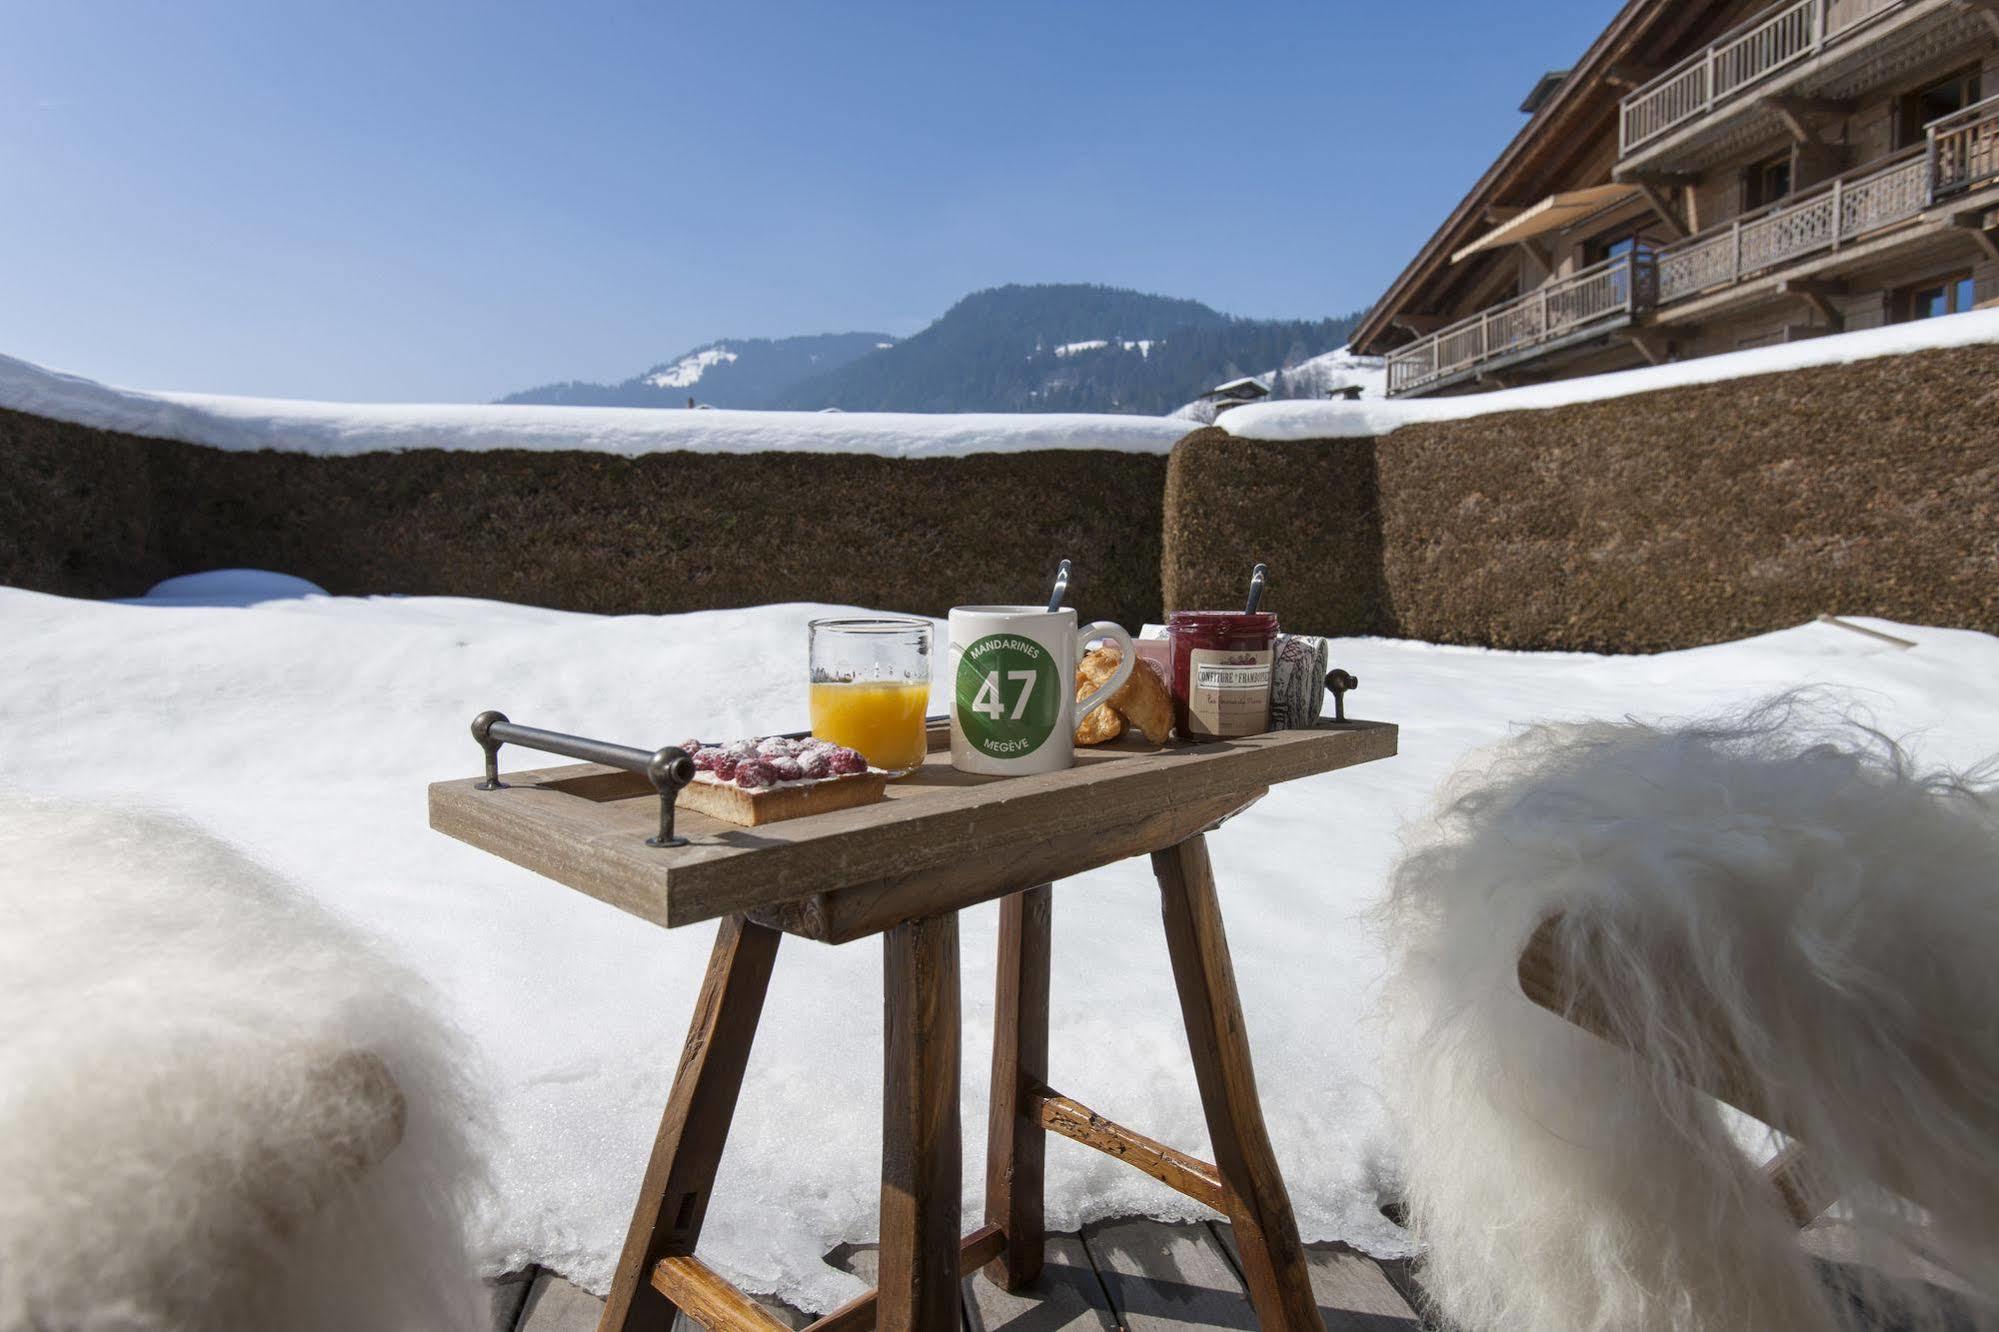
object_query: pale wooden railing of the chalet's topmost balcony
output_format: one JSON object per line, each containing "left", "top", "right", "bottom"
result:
{"left": 1617, "top": 0, "right": 1913, "bottom": 156}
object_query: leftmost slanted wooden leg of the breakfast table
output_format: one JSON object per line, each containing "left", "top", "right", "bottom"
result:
{"left": 598, "top": 916, "right": 784, "bottom": 1332}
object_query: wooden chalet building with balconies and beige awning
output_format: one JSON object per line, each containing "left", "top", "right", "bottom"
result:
{"left": 1353, "top": 0, "right": 1999, "bottom": 396}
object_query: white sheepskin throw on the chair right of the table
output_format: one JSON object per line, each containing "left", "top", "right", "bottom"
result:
{"left": 1381, "top": 698, "right": 1999, "bottom": 1332}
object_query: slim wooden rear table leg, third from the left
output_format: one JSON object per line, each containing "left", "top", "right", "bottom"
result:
{"left": 986, "top": 884, "right": 1055, "bottom": 1290}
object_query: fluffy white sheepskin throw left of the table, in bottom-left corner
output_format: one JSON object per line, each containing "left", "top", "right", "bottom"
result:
{"left": 0, "top": 792, "right": 490, "bottom": 1332}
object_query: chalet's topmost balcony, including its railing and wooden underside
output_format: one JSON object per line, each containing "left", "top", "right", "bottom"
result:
{"left": 1615, "top": 0, "right": 1993, "bottom": 180}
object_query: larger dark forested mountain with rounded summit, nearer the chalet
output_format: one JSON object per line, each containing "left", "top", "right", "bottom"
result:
{"left": 774, "top": 284, "right": 1359, "bottom": 416}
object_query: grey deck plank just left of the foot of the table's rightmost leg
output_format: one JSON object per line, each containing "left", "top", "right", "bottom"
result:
{"left": 1083, "top": 1220, "right": 1257, "bottom": 1332}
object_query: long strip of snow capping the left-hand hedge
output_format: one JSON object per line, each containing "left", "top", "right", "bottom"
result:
{"left": 0, "top": 356, "right": 1187, "bottom": 458}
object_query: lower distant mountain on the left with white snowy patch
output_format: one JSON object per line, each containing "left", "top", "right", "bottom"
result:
{"left": 500, "top": 332, "right": 896, "bottom": 408}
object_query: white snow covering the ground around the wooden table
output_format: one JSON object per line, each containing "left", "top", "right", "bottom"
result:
{"left": 0, "top": 584, "right": 1999, "bottom": 1308}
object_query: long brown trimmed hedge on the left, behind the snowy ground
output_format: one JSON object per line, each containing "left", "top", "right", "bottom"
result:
{"left": 0, "top": 402, "right": 1165, "bottom": 626}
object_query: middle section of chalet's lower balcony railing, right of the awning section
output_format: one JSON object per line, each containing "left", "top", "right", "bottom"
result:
{"left": 1659, "top": 150, "right": 1929, "bottom": 304}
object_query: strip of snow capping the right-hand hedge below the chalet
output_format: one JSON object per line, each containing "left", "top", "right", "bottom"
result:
{"left": 1223, "top": 310, "right": 1999, "bottom": 440}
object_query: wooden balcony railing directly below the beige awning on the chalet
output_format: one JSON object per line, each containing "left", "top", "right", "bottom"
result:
{"left": 1387, "top": 254, "right": 1657, "bottom": 394}
